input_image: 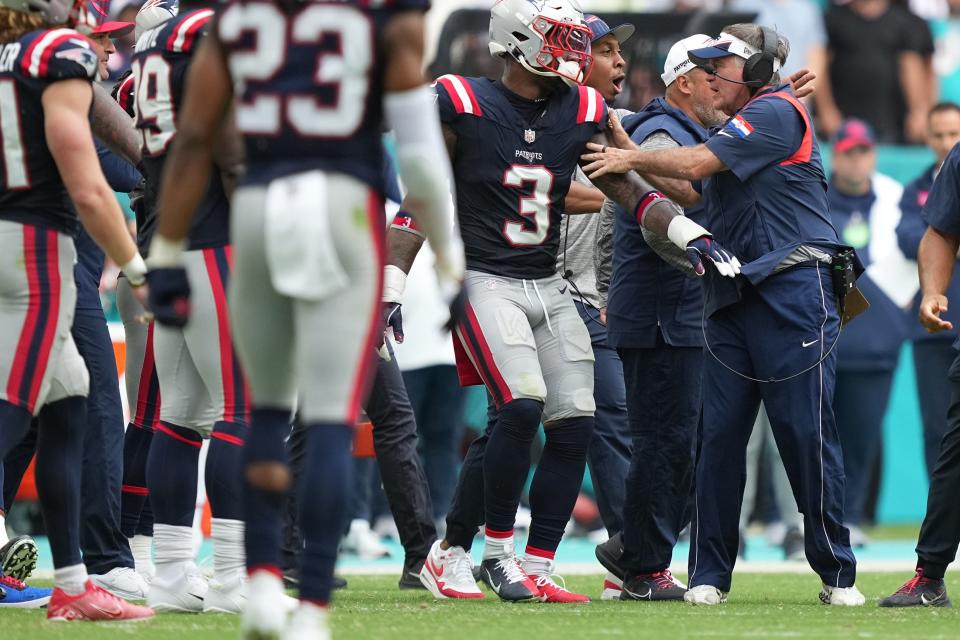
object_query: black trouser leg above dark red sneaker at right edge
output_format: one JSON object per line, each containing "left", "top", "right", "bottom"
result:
{"left": 917, "top": 356, "right": 960, "bottom": 576}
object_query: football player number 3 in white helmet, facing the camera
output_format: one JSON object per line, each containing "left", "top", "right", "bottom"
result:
{"left": 387, "top": 0, "right": 738, "bottom": 602}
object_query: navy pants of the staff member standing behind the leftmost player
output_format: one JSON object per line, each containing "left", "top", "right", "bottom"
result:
{"left": 3, "top": 306, "right": 133, "bottom": 574}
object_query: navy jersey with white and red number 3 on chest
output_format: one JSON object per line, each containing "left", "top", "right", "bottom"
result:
{"left": 436, "top": 75, "right": 607, "bottom": 278}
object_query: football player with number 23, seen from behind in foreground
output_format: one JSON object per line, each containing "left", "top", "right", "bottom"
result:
{"left": 144, "top": 0, "right": 463, "bottom": 638}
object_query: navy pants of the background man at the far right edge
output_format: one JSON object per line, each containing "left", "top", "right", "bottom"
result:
{"left": 912, "top": 337, "right": 957, "bottom": 475}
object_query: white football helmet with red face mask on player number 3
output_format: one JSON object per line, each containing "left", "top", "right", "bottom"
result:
{"left": 490, "top": 0, "right": 593, "bottom": 85}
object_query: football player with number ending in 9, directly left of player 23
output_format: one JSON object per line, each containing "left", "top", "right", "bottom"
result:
{"left": 121, "top": 2, "right": 255, "bottom": 613}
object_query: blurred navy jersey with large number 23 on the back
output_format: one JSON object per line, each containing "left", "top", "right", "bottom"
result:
{"left": 216, "top": 0, "right": 429, "bottom": 192}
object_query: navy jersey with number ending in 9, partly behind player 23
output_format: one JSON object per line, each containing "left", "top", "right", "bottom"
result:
{"left": 130, "top": 9, "right": 230, "bottom": 252}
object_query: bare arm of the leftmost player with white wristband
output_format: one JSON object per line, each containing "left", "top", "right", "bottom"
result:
{"left": 41, "top": 79, "right": 147, "bottom": 288}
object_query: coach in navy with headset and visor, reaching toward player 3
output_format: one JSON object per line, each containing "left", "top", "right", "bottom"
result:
{"left": 584, "top": 24, "right": 864, "bottom": 605}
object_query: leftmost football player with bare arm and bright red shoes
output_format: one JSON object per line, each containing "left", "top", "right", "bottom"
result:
{"left": 0, "top": 0, "right": 153, "bottom": 620}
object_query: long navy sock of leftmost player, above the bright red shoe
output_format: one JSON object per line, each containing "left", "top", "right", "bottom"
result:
{"left": 36, "top": 397, "right": 87, "bottom": 568}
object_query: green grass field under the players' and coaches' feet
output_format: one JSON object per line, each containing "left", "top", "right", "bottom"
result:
{"left": 7, "top": 573, "right": 960, "bottom": 640}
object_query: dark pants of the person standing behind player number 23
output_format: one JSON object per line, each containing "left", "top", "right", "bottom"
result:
{"left": 283, "top": 344, "right": 437, "bottom": 568}
